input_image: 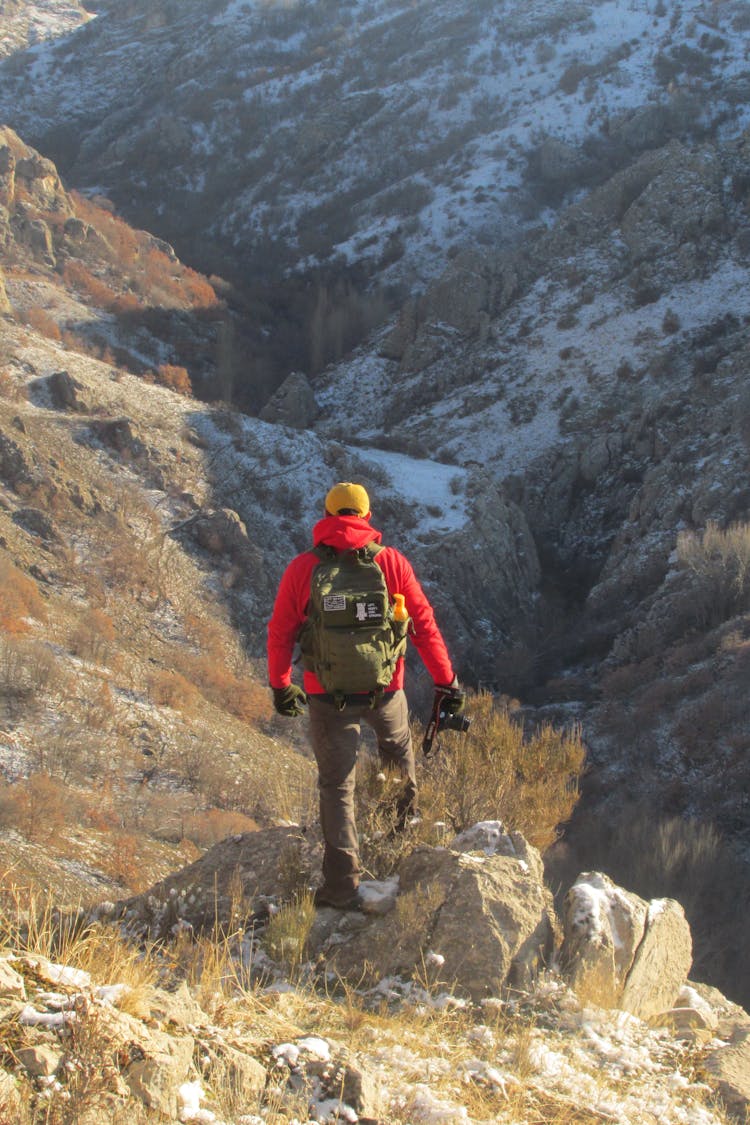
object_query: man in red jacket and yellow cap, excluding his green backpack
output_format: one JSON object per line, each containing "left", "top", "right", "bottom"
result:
{"left": 268, "top": 482, "right": 466, "bottom": 909}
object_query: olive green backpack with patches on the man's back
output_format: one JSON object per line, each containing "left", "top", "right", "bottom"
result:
{"left": 298, "top": 543, "right": 408, "bottom": 702}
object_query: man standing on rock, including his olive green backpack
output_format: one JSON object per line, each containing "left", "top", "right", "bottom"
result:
{"left": 268, "top": 482, "right": 466, "bottom": 909}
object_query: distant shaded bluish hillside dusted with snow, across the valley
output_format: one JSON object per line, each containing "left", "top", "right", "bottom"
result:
{"left": 0, "top": 0, "right": 749, "bottom": 396}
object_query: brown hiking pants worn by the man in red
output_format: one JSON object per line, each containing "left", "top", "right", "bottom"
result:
{"left": 308, "top": 691, "right": 417, "bottom": 901}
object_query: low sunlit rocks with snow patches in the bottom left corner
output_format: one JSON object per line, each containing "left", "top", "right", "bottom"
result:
{"left": 0, "top": 954, "right": 266, "bottom": 1125}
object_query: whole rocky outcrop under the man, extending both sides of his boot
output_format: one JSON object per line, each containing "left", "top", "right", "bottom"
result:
{"left": 102, "top": 824, "right": 555, "bottom": 999}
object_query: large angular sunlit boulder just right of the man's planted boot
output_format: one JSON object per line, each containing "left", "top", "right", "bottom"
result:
{"left": 316, "top": 828, "right": 555, "bottom": 1001}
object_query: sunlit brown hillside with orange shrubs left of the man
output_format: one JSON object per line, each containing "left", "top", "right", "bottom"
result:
{"left": 0, "top": 129, "right": 321, "bottom": 900}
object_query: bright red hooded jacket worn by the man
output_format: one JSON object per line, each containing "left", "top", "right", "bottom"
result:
{"left": 268, "top": 515, "right": 453, "bottom": 694}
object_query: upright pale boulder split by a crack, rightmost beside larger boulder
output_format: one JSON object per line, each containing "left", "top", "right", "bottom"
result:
{"left": 560, "top": 872, "right": 693, "bottom": 1019}
